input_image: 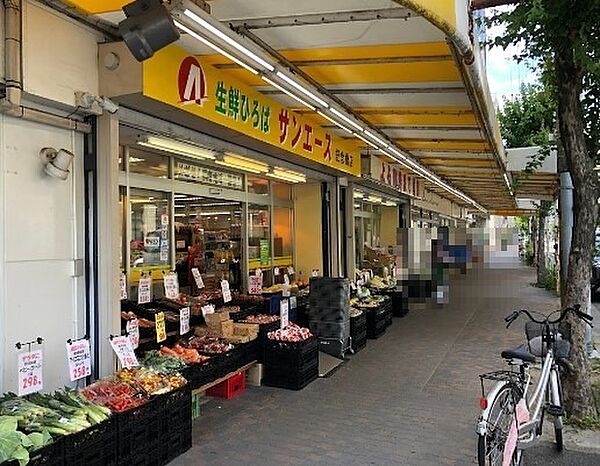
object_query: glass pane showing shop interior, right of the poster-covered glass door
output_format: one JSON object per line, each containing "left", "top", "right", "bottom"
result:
{"left": 175, "top": 194, "right": 242, "bottom": 293}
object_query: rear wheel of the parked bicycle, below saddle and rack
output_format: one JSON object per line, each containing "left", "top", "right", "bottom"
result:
{"left": 477, "top": 385, "right": 521, "bottom": 466}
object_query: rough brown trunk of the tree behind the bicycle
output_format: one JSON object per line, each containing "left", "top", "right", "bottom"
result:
{"left": 554, "top": 40, "right": 598, "bottom": 419}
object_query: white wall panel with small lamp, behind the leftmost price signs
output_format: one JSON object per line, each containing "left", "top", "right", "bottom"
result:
{"left": 0, "top": 116, "right": 84, "bottom": 392}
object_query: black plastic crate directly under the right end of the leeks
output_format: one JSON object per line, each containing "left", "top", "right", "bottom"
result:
{"left": 64, "top": 416, "right": 118, "bottom": 466}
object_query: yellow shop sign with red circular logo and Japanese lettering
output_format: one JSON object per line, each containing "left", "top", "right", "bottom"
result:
{"left": 143, "top": 45, "right": 361, "bottom": 176}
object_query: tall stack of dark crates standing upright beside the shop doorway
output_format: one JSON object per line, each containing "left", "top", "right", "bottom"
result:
{"left": 309, "top": 277, "right": 350, "bottom": 357}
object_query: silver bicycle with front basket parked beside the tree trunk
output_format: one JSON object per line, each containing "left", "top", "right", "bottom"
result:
{"left": 477, "top": 305, "right": 592, "bottom": 466}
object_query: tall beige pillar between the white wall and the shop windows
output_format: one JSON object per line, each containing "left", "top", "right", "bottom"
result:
{"left": 96, "top": 112, "right": 119, "bottom": 376}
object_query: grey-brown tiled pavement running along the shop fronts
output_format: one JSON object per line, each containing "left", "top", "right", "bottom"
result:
{"left": 173, "top": 268, "right": 596, "bottom": 466}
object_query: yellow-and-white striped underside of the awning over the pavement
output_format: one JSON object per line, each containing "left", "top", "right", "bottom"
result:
{"left": 63, "top": 0, "right": 517, "bottom": 213}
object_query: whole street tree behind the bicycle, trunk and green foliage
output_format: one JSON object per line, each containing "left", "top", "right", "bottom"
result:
{"left": 486, "top": 0, "right": 600, "bottom": 419}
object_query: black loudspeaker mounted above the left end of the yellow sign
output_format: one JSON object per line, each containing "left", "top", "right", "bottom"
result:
{"left": 119, "top": 0, "right": 179, "bottom": 61}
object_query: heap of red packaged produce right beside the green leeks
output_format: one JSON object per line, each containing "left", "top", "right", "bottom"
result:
{"left": 81, "top": 379, "right": 148, "bottom": 413}
